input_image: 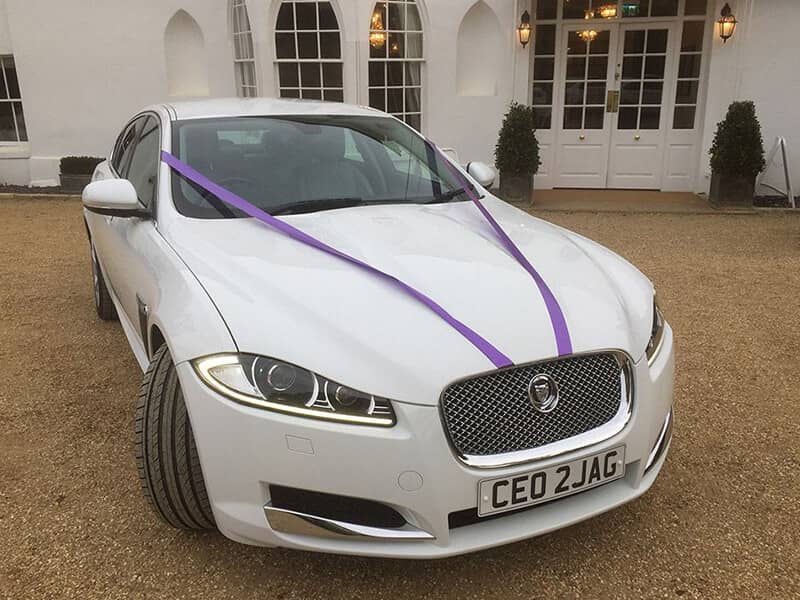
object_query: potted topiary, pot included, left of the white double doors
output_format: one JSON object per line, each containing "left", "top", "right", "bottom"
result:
{"left": 494, "top": 102, "right": 541, "bottom": 204}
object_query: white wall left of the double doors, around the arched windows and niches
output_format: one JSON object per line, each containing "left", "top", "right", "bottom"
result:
{"left": 0, "top": 0, "right": 518, "bottom": 185}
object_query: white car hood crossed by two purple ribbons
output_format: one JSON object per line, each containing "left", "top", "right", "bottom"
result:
{"left": 162, "top": 196, "right": 653, "bottom": 405}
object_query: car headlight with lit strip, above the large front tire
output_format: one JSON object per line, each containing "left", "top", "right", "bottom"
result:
{"left": 192, "top": 354, "right": 397, "bottom": 427}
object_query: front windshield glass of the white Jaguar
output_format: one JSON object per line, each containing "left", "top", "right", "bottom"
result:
{"left": 166, "top": 115, "right": 471, "bottom": 218}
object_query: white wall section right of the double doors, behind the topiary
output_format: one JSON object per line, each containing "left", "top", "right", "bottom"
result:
{"left": 697, "top": 0, "right": 800, "bottom": 193}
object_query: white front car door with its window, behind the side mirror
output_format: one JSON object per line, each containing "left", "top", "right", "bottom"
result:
{"left": 101, "top": 115, "right": 161, "bottom": 347}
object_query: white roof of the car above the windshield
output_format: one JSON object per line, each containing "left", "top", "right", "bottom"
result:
{"left": 155, "top": 98, "right": 387, "bottom": 121}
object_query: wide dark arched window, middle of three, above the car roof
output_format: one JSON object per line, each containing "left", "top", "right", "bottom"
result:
{"left": 275, "top": 0, "right": 344, "bottom": 102}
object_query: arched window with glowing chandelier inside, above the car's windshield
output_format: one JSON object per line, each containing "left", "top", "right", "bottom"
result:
{"left": 369, "top": 0, "right": 423, "bottom": 130}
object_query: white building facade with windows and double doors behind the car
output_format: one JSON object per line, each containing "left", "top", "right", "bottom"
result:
{"left": 0, "top": 0, "right": 800, "bottom": 192}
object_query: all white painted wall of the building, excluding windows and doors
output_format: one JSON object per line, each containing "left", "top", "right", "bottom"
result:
{"left": 0, "top": 0, "right": 800, "bottom": 197}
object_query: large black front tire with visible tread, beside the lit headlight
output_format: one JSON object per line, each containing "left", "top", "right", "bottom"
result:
{"left": 135, "top": 345, "right": 215, "bottom": 529}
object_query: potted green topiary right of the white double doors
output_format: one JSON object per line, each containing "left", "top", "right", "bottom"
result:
{"left": 709, "top": 100, "right": 765, "bottom": 206}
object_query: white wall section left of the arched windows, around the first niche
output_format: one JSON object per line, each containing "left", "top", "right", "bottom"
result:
{"left": 0, "top": 0, "right": 234, "bottom": 185}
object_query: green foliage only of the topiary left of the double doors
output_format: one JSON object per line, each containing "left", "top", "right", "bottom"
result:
{"left": 494, "top": 102, "right": 542, "bottom": 176}
